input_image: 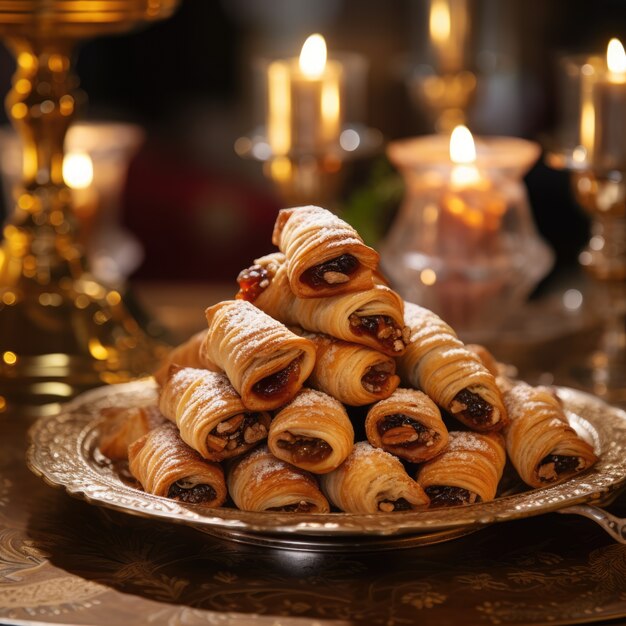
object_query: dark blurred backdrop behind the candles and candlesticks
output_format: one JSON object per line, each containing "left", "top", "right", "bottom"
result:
{"left": 0, "top": 0, "right": 626, "bottom": 282}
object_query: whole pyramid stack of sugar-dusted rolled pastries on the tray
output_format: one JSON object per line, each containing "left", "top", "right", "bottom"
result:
{"left": 101, "top": 206, "right": 596, "bottom": 513}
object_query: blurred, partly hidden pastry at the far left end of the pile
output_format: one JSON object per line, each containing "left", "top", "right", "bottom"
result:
{"left": 98, "top": 405, "right": 166, "bottom": 461}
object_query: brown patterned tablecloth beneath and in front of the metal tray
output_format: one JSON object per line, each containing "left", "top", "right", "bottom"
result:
{"left": 0, "top": 415, "right": 626, "bottom": 626}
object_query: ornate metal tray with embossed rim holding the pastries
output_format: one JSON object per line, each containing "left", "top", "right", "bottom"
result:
{"left": 27, "top": 379, "right": 626, "bottom": 551}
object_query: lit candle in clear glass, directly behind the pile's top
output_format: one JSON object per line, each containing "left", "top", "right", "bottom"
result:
{"left": 266, "top": 34, "right": 343, "bottom": 156}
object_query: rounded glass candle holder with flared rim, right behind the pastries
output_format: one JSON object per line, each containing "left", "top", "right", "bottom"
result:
{"left": 381, "top": 130, "right": 553, "bottom": 341}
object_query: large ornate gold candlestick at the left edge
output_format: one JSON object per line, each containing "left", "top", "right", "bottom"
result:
{"left": 0, "top": 0, "right": 177, "bottom": 414}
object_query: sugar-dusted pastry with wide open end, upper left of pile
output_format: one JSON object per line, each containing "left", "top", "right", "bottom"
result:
{"left": 200, "top": 300, "right": 315, "bottom": 411}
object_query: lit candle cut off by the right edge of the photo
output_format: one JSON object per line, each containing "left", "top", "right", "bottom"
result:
{"left": 592, "top": 39, "right": 626, "bottom": 171}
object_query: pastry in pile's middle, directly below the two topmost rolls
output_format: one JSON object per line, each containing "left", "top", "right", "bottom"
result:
{"left": 304, "top": 333, "right": 400, "bottom": 406}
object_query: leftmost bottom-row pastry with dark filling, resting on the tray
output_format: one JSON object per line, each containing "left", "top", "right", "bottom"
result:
{"left": 128, "top": 423, "right": 227, "bottom": 506}
